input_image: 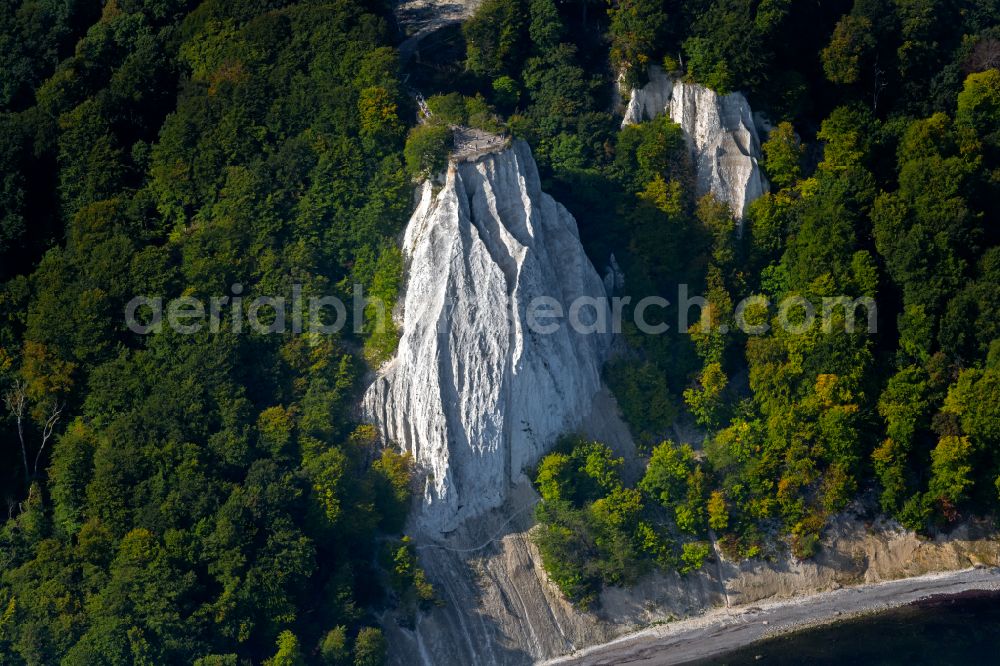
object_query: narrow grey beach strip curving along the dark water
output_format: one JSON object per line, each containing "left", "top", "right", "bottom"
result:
{"left": 541, "top": 567, "right": 1000, "bottom": 666}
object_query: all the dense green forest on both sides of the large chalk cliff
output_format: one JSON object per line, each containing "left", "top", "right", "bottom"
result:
{"left": 0, "top": 0, "right": 1000, "bottom": 666}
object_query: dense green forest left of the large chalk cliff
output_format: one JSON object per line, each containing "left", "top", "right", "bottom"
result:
{"left": 0, "top": 1, "right": 428, "bottom": 664}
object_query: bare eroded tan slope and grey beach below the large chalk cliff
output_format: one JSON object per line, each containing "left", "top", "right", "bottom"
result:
{"left": 385, "top": 487, "right": 1000, "bottom": 666}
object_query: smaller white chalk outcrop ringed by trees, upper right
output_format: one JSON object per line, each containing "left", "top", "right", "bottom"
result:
{"left": 622, "top": 65, "right": 768, "bottom": 218}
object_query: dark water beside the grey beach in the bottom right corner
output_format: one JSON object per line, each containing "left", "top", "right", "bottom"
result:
{"left": 699, "top": 593, "right": 1000, "bottom": 666}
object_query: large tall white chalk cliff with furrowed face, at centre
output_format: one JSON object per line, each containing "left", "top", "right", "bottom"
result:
{"left": 363, "top": 141, "right": 611, "bottom": 533}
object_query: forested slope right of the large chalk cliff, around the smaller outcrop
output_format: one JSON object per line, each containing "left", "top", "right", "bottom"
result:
{"left": 404, "top": 0, "right": 1000, "bottom": 601}
